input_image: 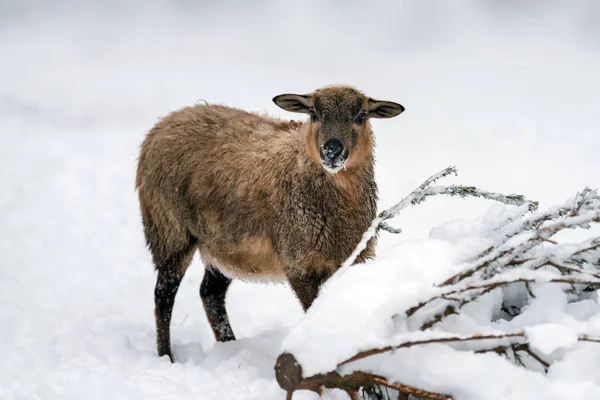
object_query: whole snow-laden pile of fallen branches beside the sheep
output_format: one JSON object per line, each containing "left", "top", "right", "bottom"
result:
{"left": 276, "top": 167, "right": 600, "bottom": 400}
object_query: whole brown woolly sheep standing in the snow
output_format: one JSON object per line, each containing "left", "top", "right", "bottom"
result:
{"left": 136, "top": 86, "right": 404, "bottom": 360}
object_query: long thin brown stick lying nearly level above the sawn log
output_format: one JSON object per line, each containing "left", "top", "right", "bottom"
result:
{"left": 338, "top": 331, "right": 600, "bottom": 367}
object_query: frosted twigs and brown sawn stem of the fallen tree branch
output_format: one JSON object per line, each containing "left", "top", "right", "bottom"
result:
{"left": 275, "top": 177, "right": 600, "bottom": 400}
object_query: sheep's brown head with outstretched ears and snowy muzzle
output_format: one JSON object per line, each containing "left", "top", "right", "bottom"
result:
{"left": 273, "top": 86, "right": 404, "bottom": 173}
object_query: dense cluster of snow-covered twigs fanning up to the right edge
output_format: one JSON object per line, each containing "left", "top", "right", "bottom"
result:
{"left": 406, "top": 188, "right": 600, "bottom": 329}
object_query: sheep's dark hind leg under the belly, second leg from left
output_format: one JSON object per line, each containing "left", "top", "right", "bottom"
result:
{"left": 200, "top": 265, "right": 235, "bottom": 342}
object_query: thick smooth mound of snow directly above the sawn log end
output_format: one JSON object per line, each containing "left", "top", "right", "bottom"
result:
{"left": 282, "top": 241, "right": 454, "bottom": 376}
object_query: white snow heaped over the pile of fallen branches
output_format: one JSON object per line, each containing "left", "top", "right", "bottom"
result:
{"left": 282, "top": 206, "right": 600, "bottom": 399}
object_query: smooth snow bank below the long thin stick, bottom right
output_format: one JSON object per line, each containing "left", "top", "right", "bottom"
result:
{"left": 342, "top": 345, "right": 600, "bottom": 400}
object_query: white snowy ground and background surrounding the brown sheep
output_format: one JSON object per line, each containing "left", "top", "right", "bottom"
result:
{"left": 0, "top": 0, "right": 600, "bottom": 400}
